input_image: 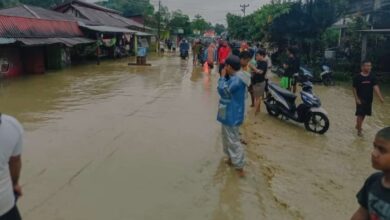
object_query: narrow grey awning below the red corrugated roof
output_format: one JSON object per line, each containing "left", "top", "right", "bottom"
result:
{"left": 16, "top": 37, "right": 95, "bottom": 47}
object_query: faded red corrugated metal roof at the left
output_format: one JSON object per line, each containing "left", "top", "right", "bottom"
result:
{"left": 0, "top": 15, "right": 83, "bottom": 38}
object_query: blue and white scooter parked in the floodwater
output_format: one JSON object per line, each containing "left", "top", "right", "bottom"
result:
{"left": 264, "top": 81, "right": 329, "bottom": 134}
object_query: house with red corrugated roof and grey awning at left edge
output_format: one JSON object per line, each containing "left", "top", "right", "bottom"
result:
{"left": 0, "top": 5, "right": 95, "bottom": 76}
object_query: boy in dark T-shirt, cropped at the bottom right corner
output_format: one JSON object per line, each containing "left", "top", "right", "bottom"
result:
{"left": 352, "top": 127, "right": 390, "bottom": 220}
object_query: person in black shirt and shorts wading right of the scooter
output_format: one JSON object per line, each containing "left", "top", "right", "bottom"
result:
{"left": 353, "top": 61, "right": 384, "bottom": 136}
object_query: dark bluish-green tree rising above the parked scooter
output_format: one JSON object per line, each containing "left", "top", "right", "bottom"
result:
{"left": 268, "top": 0, "right": 341, "bottom": 63}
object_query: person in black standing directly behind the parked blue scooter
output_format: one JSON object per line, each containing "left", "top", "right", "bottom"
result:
{"left": 283, "top": 48, "right": 301, "bottom": 93}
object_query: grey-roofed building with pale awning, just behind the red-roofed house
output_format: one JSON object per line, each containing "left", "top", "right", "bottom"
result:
{"left": 54, "top": 0, "right": 155, "bottom": 52}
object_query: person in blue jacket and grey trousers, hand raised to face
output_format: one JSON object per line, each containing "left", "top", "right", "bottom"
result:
{"left": 218, "top": 55, "right": 250, "bottom": 177}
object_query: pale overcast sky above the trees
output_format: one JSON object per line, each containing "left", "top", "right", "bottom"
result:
{"left": 87, "top": 0, "right": 270, "bottom": 24}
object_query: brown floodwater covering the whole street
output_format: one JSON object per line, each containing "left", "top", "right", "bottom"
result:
{"left": 0, "top": 55, "right": 390, "bottom": 220}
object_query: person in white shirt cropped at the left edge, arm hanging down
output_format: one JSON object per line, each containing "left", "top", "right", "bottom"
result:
{"left": 0, "top": 114, "right": 23, "bottom": 220}
